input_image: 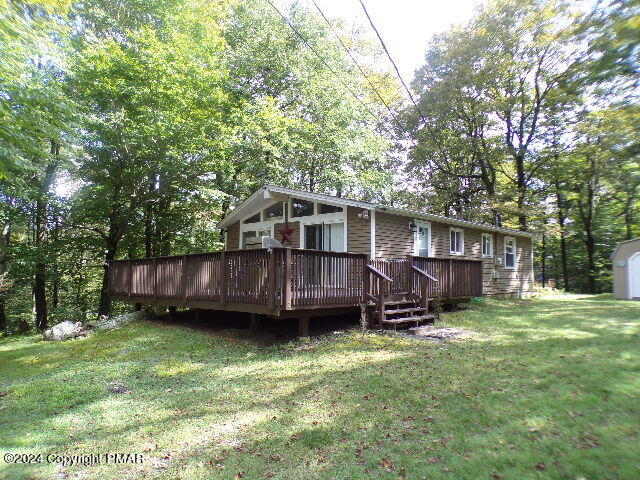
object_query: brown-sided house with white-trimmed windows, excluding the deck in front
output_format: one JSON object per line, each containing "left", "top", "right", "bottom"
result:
{"left": 219, "top": 185, "right": 534, "bottom": 297}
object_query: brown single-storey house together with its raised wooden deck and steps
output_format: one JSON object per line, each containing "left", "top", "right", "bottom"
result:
{"left": 109, "top": 185, "right": 533, "bottom": 336}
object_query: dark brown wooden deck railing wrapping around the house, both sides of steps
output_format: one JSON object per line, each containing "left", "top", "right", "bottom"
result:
{"left": 109, "top": 248, "right": 482, "bottom": 316}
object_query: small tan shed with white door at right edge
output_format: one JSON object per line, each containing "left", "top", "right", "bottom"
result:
{"left": 611, "top": 238, "right": 640, "bottom": 300}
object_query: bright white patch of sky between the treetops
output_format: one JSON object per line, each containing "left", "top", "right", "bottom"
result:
{"left": 299, "top": 0, "right": 481, "bottom": 83}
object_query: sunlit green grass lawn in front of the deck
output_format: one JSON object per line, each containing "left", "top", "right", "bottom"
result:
{"left": 0, "top": 295, "right": 640, "bottom": 480}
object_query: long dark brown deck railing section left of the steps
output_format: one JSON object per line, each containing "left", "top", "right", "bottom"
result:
{"left": 109, "top": 248, "right": 367, "bottom": 310}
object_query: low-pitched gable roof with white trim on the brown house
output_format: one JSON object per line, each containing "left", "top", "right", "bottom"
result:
{"left": 218, "top": 185, "right": 536, "bottom": 238}
